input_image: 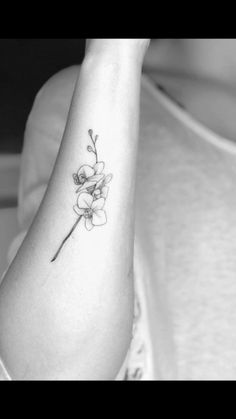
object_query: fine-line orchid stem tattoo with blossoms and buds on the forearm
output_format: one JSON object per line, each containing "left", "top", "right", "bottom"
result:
{"left": 51, "top": 129, "right": 112, "bottom": 262}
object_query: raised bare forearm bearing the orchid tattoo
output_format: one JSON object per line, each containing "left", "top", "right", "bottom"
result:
{"left": 0, "top": 40, "right": 147, "bottom": 379}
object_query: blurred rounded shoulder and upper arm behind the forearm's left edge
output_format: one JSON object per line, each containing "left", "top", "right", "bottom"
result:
{"left": 18, "top": 66, "right": 80, "bottom": 230}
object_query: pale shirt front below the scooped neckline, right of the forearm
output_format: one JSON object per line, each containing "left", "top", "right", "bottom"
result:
{"left": 124, "top": 75, "right": 236, "bottom": 379}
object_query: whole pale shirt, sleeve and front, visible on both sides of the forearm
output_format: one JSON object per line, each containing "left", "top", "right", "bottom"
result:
{"left": 2, "top": 67, "right": 236, "bottom": 380}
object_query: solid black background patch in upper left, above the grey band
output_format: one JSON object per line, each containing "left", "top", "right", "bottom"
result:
{"left": 0, "top": 39, "right": 85, "bottom": 153}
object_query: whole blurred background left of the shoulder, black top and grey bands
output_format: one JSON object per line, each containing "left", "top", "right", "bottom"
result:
{"left": 0, "top": 39, "right": 85, "bottom": 277}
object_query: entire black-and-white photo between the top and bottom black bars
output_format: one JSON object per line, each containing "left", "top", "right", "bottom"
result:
{"left": 0, "top": 38, "right": 236, "bottom": 381}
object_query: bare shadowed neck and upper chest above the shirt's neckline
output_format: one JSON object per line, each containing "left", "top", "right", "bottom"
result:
{"left": 144, "top": 39, "right": 236, "bottom": 141}
